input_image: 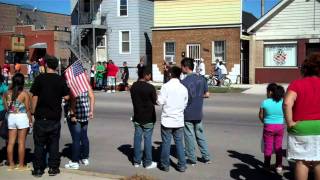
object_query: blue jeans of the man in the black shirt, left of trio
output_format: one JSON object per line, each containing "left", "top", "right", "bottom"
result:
{"left": 133, "top": 124, "right": 153, "bottom": 167}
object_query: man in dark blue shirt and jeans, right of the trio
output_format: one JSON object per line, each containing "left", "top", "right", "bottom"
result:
{"left": 181, "top": 58, "right": 211, "bottom": 166}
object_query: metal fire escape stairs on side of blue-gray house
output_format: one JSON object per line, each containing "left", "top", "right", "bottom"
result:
{"left": 67, "top": 0, "right": 107, "bottom": 67}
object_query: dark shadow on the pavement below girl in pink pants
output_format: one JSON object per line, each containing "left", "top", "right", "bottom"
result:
{"left": 227, "top": 150, "right": 293, "bottom": 180}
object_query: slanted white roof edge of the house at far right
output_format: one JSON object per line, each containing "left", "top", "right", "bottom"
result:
{"left": 248, "top": 0, "right": 294, "bottom": 32}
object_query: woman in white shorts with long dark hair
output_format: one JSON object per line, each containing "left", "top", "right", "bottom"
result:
{"left": 7, "top": 73, "right": 32, "bottom": 171}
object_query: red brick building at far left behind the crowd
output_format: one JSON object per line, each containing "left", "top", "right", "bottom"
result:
{"left": 0, "top": 3, "right": 71, "bottom": 72}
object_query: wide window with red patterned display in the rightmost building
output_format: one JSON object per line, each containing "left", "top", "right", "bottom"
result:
{"left": 264, "top": 43, "right": 297, "bottom": 67}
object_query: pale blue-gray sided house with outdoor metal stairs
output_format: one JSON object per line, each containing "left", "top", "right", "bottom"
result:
{"left": 71, "top": 0, "right": 154, "bottom": 78}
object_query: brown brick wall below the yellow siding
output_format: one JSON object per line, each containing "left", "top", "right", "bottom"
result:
{"left": 152, "top": 28, "right": 240, "bottom": 74}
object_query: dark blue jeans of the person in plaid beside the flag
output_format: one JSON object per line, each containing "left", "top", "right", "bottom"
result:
{"left": 67, "top": 120, "right": 89, "bottom": 162}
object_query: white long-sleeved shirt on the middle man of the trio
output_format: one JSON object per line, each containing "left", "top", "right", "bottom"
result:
{"left": 157, "top": 79, "right": 188, "bottom": 128}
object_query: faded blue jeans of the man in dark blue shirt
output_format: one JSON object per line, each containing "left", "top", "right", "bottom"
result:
{"left": 184, "top": 122, "right": 210, "bottom": 163}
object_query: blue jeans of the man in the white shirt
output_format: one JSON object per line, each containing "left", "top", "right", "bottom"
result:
{"left": 160, "top": 126, "right": 186, "bottom": 169}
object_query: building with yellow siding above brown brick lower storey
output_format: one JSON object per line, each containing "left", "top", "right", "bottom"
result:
{"left": 152, "top": 0, "right": 242, "bottom": 81}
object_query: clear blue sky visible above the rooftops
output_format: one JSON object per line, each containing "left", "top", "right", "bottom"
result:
{"left": 0, "top": 0, "right": 279, "bottom": 17}
